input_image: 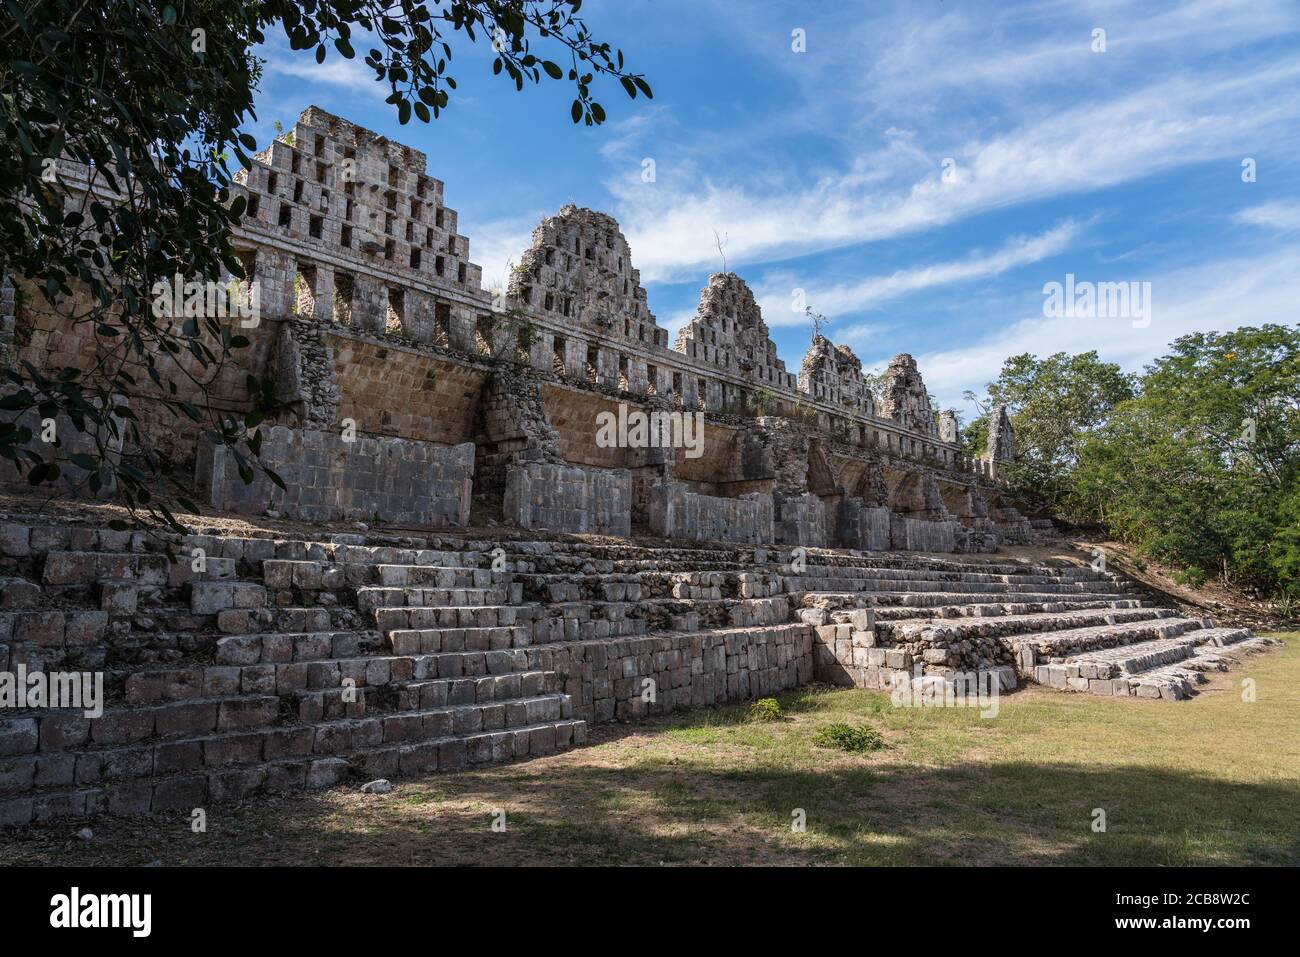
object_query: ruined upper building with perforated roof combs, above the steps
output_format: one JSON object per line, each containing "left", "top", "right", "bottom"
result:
{"left": 0, "top": 108, "right": 1026, "bottom": 553}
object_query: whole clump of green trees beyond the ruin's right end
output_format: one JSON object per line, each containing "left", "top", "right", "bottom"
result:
{"left": 972, "top": 324, "right": 1300, "bottom": 596}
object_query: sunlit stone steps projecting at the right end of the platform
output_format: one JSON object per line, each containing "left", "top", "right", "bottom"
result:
{"left": 789, "top": 559, "right": 1277, "bottom": 700}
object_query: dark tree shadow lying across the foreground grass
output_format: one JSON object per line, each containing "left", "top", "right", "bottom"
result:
{"left": 12, "top": 759, "right": 1300, "bottom": 866}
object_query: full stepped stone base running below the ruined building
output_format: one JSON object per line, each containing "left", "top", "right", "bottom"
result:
{"left": 0, "top": 523, "right": 1268, "bottom": 824}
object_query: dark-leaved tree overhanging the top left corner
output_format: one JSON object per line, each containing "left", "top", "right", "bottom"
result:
{"left": 0, "top": 0, "right": 651, "bottom": 528}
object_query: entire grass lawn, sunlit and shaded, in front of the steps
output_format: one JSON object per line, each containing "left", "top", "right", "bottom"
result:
{"left": 0, "top": 633, "right": 1300, "bottom": 866}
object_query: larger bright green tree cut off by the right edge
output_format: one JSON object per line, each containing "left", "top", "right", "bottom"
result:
{"left": 1070, "top": 325, "right": 1300, "bottom": 592}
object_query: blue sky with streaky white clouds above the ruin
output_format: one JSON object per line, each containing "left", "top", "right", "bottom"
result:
{"left": 251, "top": 0, "right": 1300, "bottom": 415}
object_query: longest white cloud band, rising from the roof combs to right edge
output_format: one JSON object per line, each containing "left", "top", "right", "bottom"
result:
{"left": 610, "top": 57, "right": 1300, "bottom": 282}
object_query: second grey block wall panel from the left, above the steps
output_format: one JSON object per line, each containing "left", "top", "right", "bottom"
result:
{"left": 503, "top": 462, "right": 632, "bottom": 536}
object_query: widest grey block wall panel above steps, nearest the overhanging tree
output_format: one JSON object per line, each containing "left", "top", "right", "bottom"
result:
{"left": 195, "top": 426, "right": 475, "bottom": 525}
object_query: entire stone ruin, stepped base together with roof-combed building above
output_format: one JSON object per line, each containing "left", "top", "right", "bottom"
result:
{"left": 0, "top": 108, "right": 1265, "bottom": 824}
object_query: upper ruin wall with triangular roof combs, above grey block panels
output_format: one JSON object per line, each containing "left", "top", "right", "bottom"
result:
{"left": 10, "top": 107, "right": 1015, "bottom": 544}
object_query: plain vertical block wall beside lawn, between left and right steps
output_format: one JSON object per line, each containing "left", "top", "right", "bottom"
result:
{"left": 528, "top": 624, "right": 814, "bottom": 722}
